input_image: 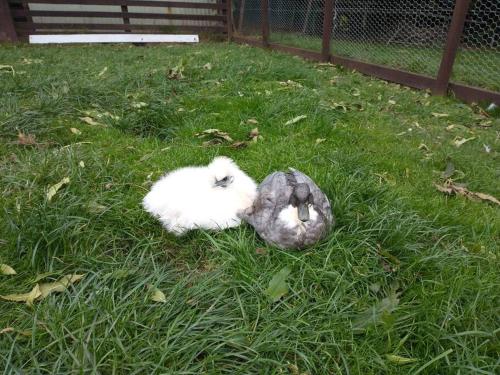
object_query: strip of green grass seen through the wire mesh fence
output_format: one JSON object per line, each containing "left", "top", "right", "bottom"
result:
{"left": 271, "top": 32, "right": 500, "bottom": 91}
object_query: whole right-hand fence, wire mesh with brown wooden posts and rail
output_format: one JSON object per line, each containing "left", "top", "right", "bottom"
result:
{"left": 233, "top": 0, "right": 500, "bottom": 104}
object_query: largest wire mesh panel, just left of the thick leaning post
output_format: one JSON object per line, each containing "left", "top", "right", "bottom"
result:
{"left": 331, "top": 0, "right": 454, "bottom": 76}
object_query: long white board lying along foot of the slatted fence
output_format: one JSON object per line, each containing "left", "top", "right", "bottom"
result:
{"left": 30, "top": 33, "right": 199, "bottom": 44}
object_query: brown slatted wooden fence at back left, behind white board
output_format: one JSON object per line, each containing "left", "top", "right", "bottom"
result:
{"left": 0, "top": 0, "right": 231, "bottom": 41}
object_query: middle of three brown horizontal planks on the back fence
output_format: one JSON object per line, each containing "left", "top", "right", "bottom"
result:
{"left": 12, "top": 9, "right": 226, "bottom": 21}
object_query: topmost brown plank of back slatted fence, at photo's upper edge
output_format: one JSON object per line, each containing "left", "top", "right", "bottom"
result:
{"left": 8, "top": 0, "right": 226, "bottom": 9}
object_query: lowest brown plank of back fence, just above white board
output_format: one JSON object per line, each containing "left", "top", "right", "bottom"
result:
{"left": 15, "top": 22, "right": 226, "bottom": 32}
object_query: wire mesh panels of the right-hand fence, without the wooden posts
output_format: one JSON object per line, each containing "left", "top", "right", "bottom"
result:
{"left": 234, "top": 0, "right": 500, "bottom": 97}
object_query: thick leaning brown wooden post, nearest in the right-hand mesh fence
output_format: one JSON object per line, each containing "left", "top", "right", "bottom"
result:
{"left": 432, "top": 0, "right": 470, "bottom": 95}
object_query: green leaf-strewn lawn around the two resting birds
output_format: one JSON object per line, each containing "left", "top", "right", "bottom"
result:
{"left": 0, "top": 43, "right": 500, "bottom": 375}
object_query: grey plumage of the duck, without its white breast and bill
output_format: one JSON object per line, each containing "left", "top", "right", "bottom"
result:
{"left": 240, "top": 169, "right": 335, "bottom": 249}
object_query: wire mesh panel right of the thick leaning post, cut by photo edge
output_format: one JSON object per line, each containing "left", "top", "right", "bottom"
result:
{"left": 452, "top": 0, "right": 500, "bottom": 91}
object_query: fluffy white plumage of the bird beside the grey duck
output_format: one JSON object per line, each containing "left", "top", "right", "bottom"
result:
{"left": 142, "top": 156, "right": 257, "bottom": 235}
